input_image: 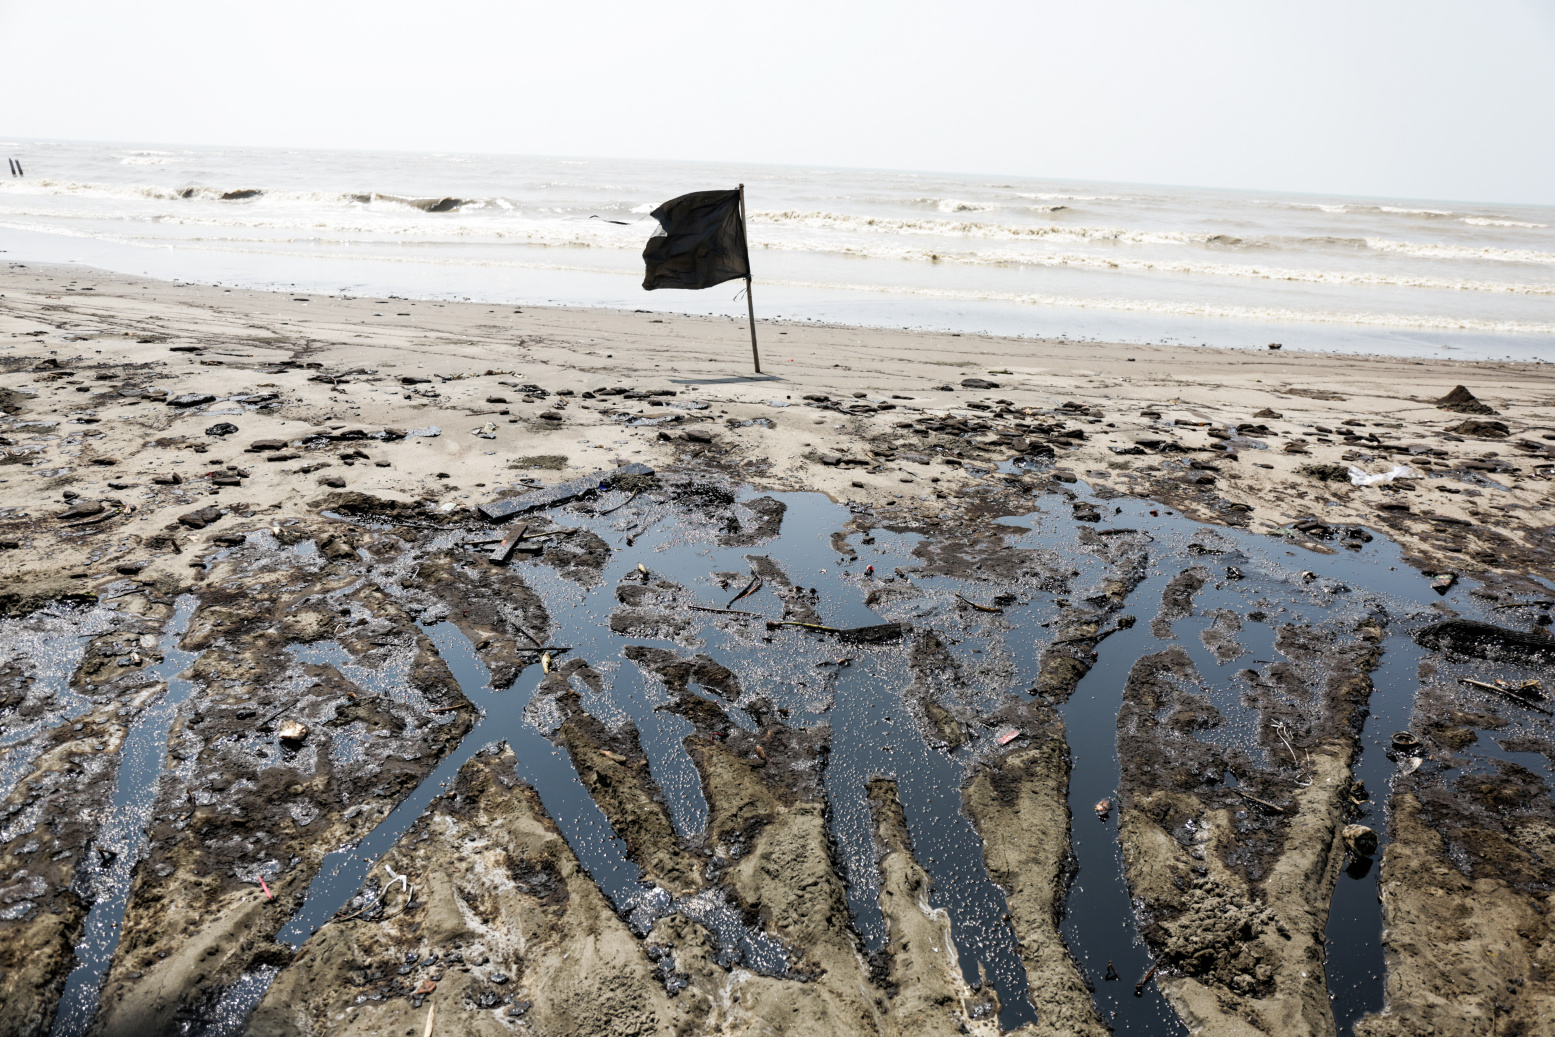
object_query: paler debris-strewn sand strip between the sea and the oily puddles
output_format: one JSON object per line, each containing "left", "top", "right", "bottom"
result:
{"left": 0, "top": 264, "right": 1555, "bottom": 575}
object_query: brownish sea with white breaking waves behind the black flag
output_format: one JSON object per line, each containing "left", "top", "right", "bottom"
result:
{"left": 0, "top": 140, "right": 1555, "bottom": 361}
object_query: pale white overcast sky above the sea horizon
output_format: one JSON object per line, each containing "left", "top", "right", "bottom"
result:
{"left": 0, "top": 0, "right": 1555, "bottom": 204}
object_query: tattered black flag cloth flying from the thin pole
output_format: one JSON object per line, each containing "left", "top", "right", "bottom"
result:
{"left": 642, "top": 191, "right": 751, "bottom": 291}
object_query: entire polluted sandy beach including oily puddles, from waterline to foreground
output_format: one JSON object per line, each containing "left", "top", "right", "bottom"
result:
{"left": 0, "top": 263, "right": 1555, "bottom": 1037}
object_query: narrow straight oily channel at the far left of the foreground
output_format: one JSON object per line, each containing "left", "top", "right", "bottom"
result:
{"left": 50, "top": 595, "right": 199, "bottom": 1037}
